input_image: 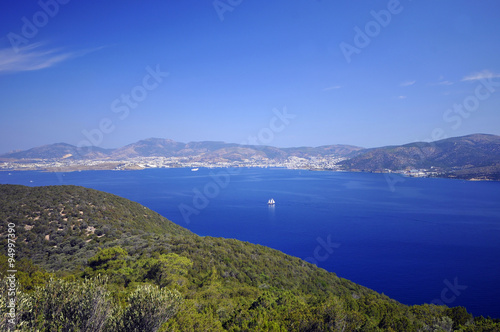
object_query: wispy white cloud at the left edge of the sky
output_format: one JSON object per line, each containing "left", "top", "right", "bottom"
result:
{"left": 0, "top": 43, "right": 102, "bottom": 74}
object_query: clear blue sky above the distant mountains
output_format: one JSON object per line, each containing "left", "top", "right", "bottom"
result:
{"left": 0, "top": 0, "right": 500, "bottom": 153}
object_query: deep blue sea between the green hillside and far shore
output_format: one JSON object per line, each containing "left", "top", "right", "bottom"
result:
{"left": 0, "top": 168, "right": 500, "bottom": 318}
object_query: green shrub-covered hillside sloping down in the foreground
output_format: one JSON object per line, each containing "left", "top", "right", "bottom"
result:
{"left": 0, "top": 185, "right": 500, "bottom": 331}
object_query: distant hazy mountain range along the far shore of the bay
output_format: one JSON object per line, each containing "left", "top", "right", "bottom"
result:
{"left": 0, "top": 134, "right": 500, "bottom": 180}
